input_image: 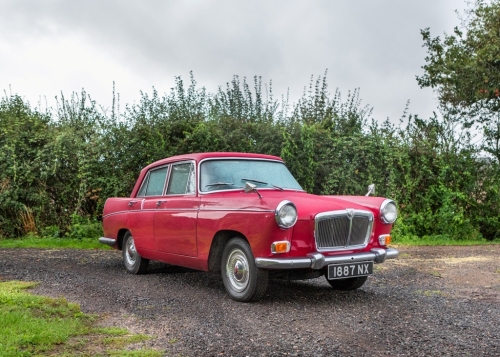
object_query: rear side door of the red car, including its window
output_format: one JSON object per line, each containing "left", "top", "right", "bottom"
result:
{"left": 128, "top": 165, "right": 170, "bottom": 250}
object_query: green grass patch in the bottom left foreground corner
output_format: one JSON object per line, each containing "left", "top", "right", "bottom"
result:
{"left": 0, "top": 281, "right": 162, "bottom": 357}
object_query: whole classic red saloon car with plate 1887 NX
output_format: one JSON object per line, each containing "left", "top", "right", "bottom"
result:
{"left": 99, "top": 152, "right": 399, "bottom": 301}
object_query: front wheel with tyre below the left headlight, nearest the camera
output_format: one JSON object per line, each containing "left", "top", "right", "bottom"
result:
{"left": 221, "top": 237, "right": 269, "bottom": 302}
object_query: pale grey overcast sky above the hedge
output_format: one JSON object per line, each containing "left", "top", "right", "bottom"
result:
{"left": 0, "top": 0, "right": 465, "bottom": 121}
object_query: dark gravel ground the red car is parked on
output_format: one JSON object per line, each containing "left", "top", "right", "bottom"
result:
{"left": 0, "top": 246, "right": 500, "bottom": 356}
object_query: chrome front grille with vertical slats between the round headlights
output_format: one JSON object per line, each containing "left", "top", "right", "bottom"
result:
{"left": 314, "top": 209, "right": 373, "bottom": 250}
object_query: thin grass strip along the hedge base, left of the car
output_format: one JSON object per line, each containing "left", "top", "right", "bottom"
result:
{"left": 0, "top": 236, "right": 111, "bottom": 249}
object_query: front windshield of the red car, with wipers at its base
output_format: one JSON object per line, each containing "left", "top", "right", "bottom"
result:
{"left": 200, "top": 159, "right": 303, "bottom": 192}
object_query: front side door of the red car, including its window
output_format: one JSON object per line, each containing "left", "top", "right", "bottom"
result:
{"left": 155, "top": 161, "right": 200, "bottom": 257}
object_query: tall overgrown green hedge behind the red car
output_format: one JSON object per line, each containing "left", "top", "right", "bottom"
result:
{"left": 0, "top": 70, "right": 500, "bottom": 241}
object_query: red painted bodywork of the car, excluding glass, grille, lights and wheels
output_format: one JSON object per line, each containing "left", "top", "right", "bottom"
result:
{"left": 103, "top": 153, "right": 392, "bottom": 270}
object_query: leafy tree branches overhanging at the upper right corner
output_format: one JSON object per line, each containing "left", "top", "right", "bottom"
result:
{"left": 417, "top": 0, "right": 500, "bottom": 161}
